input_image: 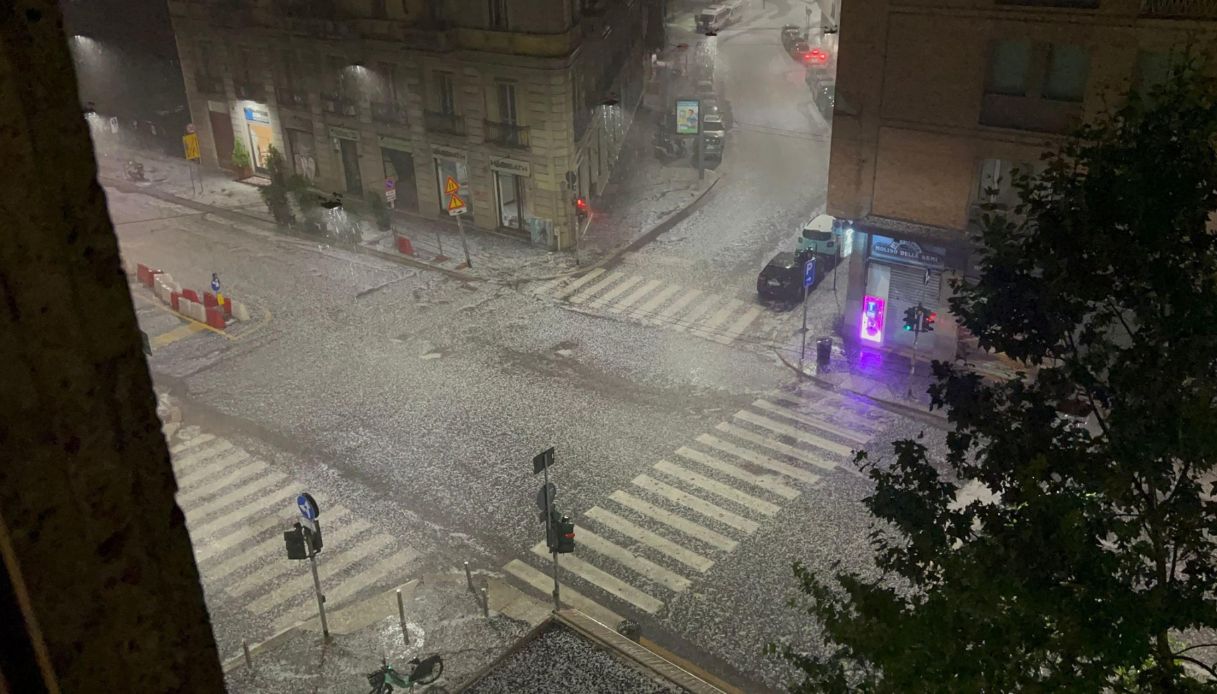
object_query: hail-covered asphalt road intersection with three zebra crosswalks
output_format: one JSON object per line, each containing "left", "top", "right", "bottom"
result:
{"left": 110, "top": 2, "right": 937, "bottom": 692}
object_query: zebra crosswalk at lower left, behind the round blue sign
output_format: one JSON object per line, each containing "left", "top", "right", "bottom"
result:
{"left": 169, "top": 427, "right": 419, "bottom": 631}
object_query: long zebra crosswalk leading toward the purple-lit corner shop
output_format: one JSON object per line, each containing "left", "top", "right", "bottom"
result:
{"left": 503, "top": 387, "right": 896, "bottom": 618}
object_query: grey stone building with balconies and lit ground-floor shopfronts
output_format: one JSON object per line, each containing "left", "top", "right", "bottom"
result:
{"left": 169, "top": 0, "right": 663, "bottom": 250}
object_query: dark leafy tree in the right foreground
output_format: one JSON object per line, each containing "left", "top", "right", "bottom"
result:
{"left": 769, "top": 58, "right": 1217, "bottom": 693}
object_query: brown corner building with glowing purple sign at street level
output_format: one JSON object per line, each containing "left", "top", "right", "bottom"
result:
{"left": 828, "top": 0, "right": 1217, "bottom": 359}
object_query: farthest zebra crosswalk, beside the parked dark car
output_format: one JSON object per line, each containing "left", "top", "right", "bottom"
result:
{"left": 529, "top": 268, "right": 778, "bottom": 345}
